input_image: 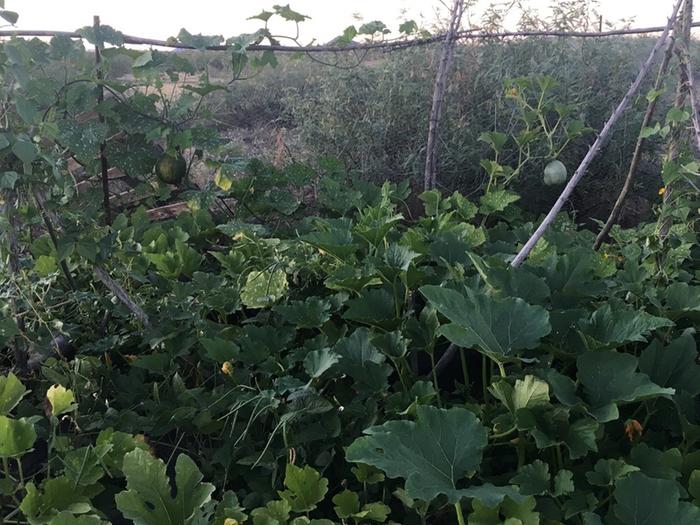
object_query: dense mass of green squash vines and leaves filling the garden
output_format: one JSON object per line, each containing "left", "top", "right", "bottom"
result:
{"left": 0, "top": 1, "right": 700, "bottom": 525}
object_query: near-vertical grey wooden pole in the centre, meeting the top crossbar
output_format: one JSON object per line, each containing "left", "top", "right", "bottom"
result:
{"left": 423, "top": 0, "right": 464, "bottom": 191}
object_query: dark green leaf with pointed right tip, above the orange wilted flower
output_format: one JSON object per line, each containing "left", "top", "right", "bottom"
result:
{"left": 576, "top": 351, "right": 675, "bottom": 422}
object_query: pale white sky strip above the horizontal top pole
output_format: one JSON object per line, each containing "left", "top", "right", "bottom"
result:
{"left": 5, "top": 0, "right": 675, "bottom": 42}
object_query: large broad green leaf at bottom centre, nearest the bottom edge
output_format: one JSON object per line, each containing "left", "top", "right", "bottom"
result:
{"left": 346, "top": 405, "right": 487, "bottom": 503}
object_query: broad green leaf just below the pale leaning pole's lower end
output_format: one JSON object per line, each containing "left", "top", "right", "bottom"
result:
{"left": 420, "top": 286, "right": 551, "bottom": 362}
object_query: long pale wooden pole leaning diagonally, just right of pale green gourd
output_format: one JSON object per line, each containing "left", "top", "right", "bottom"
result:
{"left": 510, "top": 0, "right": 684, "bottom": 267}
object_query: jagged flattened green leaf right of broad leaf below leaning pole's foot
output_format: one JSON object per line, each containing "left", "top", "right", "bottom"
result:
{"left": 581, "top": 304, "right": 673, "bottom": 344}
